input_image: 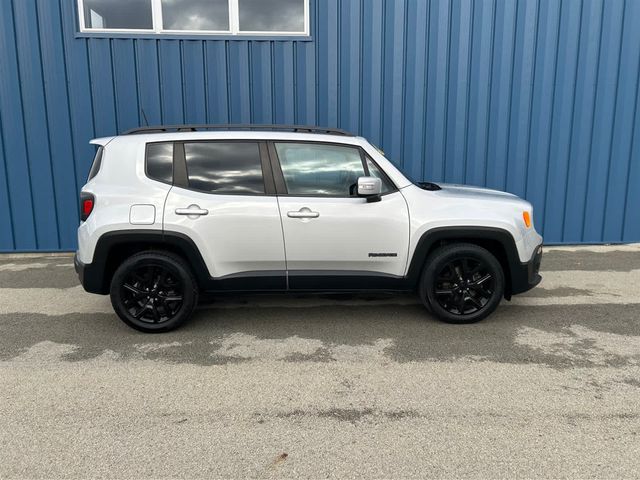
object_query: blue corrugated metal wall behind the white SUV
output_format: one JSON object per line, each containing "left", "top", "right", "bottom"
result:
{"left": 0, "top": 0, "right": 640, "bottom": 251}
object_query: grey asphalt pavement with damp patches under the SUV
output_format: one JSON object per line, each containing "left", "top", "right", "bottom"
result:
{"left": 0, "top": 245, "right": 640, "bottom": 479}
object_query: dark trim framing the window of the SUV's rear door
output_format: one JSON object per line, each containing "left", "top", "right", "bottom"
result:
{"left": 170, "top": 138, "right": 276, "bottom": 197}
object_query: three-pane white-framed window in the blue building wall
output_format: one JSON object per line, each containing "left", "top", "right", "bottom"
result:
{"left": 78, "top": 0, "right": 310, "bottom": 35}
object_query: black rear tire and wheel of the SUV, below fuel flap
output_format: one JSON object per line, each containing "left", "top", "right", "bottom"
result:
{"left": 110, "top": 250, "right": 198, "bottom": 333}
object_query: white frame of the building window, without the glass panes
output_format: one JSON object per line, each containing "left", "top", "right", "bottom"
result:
{"left": 77, "top": 0, "right": 310, "bottom": 37}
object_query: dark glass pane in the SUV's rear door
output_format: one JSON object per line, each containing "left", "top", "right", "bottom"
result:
{"left": 184, "top": 142, "right": 265, "bottom": 195}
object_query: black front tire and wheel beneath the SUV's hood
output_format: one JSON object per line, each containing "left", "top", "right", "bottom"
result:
{"left": 418, "top": 243, "right": 505, "bottom": 324}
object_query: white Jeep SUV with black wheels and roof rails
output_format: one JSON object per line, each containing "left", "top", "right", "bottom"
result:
{"left": 75, "top": 125, "right": 542, "bottom": 332}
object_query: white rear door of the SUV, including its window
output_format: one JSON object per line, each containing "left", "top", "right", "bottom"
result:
{"left": 164, "top": 140, "right": 286, "bottom": 290}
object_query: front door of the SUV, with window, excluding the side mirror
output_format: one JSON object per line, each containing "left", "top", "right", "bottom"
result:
{"left": 270, "top": 142, "right": 409, "bottom": 290}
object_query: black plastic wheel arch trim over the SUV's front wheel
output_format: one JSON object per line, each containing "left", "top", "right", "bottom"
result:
{"left": 407, "top": 227, "right": 520, "bottom": 299}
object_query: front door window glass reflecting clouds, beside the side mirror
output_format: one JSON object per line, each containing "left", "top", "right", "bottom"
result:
{"left": 275, "top": 143, "right": 365, "bottom": 197}
